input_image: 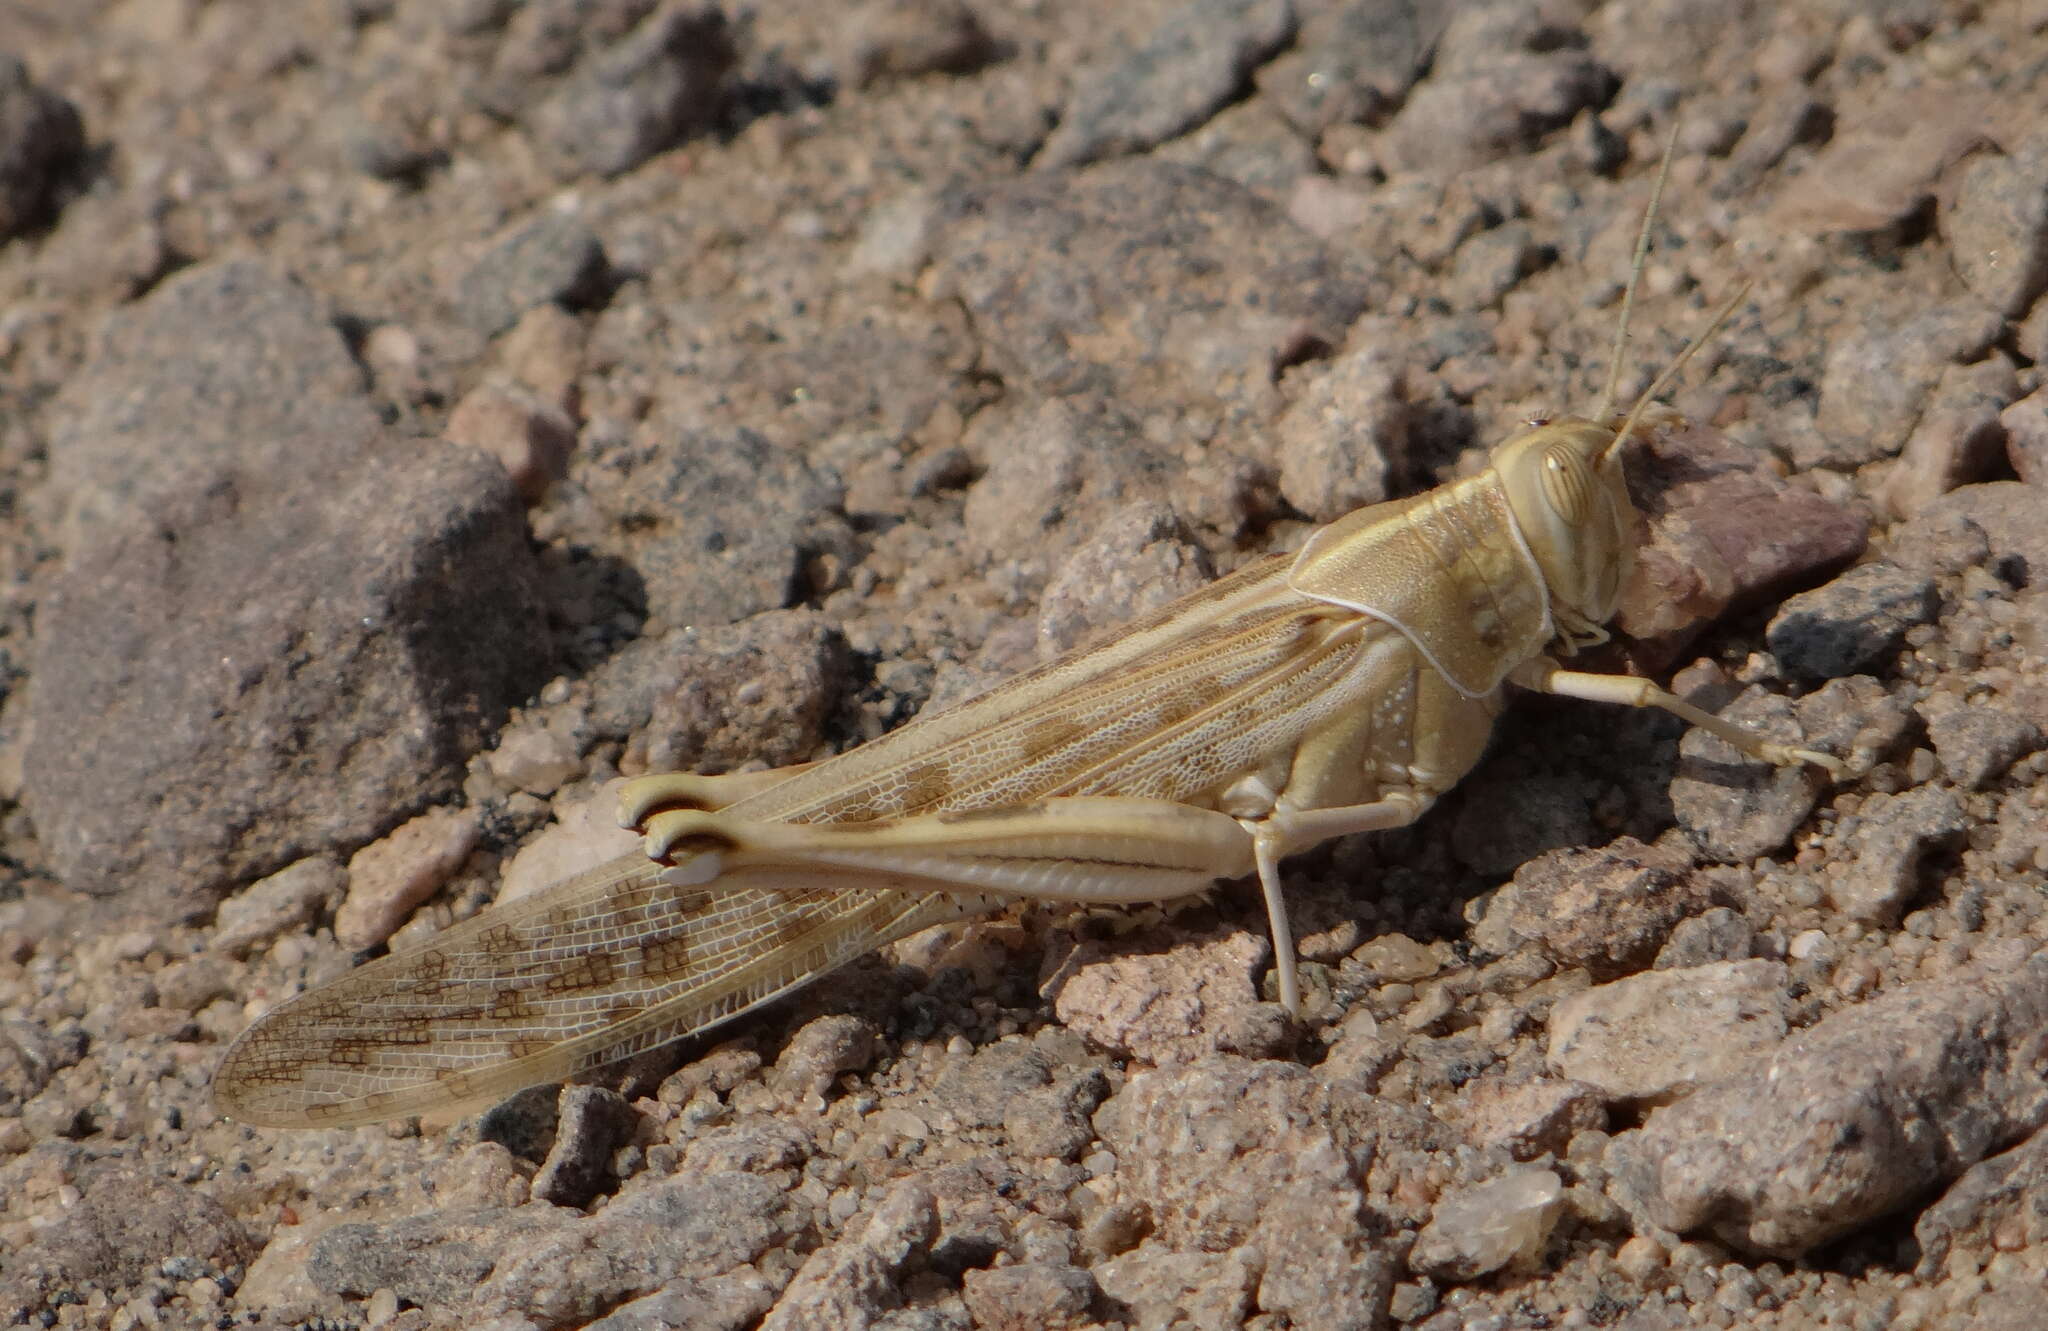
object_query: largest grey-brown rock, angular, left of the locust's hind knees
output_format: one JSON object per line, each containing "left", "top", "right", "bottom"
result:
{"left": 27, "top": 440, "right": 551, "bottom": 911}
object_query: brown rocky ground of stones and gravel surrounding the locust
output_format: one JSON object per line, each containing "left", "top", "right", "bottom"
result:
{"left": 0, "top": 0, "right": 2048, "bottom": 1331}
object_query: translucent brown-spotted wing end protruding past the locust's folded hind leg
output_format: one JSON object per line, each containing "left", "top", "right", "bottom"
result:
{"left": 213, "top": 854, "right": 993, "bottom": 1128}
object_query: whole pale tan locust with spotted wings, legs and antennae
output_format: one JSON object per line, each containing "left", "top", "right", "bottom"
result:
{"left": 213, "top": 149, "right": 1841, "bottom": 1126}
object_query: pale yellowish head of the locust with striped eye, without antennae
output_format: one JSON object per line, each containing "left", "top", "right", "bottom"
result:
{"left": 1493, "top": 416, "right": 1636, "bottom": 651}
